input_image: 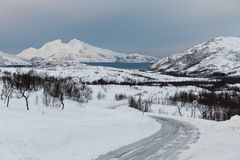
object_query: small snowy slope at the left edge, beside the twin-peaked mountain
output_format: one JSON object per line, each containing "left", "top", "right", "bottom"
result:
{"left": 0, "top": 52, "right": 31, "bottom": 67}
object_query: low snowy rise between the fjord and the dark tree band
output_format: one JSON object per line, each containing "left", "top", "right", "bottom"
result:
{"left": 0, "top": 63, "right": 208, "bottom": 82}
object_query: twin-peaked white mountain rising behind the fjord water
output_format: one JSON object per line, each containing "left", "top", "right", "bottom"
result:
{"left": 17, "top": 39, "right": 158, "bottom": 62}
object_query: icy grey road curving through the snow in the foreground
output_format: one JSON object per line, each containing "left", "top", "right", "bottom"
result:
{"left": 96, "top": 117, "right": 200, "bottom": 160}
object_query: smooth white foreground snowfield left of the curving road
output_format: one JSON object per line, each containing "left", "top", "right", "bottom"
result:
{"left": 0, "top": 87, "right": 161, "bottom": 160}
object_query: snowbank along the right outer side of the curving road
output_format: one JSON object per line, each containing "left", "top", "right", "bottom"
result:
{"left": 150, "top": 114, "right": 240, "bottom": 160}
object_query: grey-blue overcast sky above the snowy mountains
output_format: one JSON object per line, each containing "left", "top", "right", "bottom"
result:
{"left": 0, "top": 0, "right": 240, "bottom": 57}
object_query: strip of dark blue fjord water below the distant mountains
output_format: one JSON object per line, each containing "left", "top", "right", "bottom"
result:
{"left": 85, "top": 62, "right": 152, "bottom": 70}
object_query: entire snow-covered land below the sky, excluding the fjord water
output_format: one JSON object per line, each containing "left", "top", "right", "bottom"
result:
{"left": 0, "top": 37, "right": 240, "bottom": 160}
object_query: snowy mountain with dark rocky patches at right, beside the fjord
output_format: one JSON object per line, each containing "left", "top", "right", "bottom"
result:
{"left": 150, "top": 37, "right": 240, "bottom": 77}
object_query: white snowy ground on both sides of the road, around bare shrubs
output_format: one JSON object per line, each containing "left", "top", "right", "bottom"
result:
{"left": 0, "top": 73, "right": 240, "bottom": 160}
